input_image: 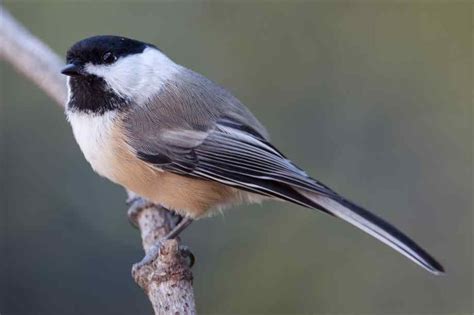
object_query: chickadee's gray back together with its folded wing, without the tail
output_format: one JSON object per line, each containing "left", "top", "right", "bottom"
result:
{"left": 124, "top": 68, "right": 329, "bottom": 206}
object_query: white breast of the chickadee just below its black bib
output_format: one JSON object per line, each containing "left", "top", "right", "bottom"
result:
{"left": 67, "top": 111, "right": 122, "bottom": 181}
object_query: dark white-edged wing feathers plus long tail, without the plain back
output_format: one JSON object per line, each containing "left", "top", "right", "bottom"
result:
{"left": 134, "top": 118, "right": 443, "bottom": 274}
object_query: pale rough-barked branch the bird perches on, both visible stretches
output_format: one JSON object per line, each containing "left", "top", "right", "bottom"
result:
{"left": 0, "top": 5, "right": 196, "bottom": 314}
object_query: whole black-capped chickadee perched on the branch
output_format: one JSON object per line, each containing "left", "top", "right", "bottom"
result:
{"left": 62, "top": 36, "right": 444, "bottom": 274}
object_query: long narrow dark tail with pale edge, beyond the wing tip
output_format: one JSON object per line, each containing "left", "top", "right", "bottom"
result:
{"left": 295, "top": 189, "right": 444, "bottom": 275}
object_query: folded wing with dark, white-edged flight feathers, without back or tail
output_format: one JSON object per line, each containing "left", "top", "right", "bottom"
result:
{"left": 137, "top": 117, "right": 334, "bottom": 211}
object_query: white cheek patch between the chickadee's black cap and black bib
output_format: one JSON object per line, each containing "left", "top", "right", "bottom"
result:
{"left": 85, "top": 47, "right": 181, "bottom": 104}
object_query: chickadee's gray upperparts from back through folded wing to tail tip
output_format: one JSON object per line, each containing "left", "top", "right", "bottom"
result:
{"left": 125, "top": 67, "right": 443, "bottom": 274}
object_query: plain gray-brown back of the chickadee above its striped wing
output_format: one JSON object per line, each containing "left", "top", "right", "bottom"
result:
{"left": 124, "top": 68, "right": 268, "bottom": 150}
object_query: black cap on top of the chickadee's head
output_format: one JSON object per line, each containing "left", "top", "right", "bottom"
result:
{"left": 66, "top": 35, "right": 156, "bottom": 64}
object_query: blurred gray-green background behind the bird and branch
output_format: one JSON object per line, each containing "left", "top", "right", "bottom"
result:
{"left": 0, "top": 1, "right": 473, "bottom": 315}
